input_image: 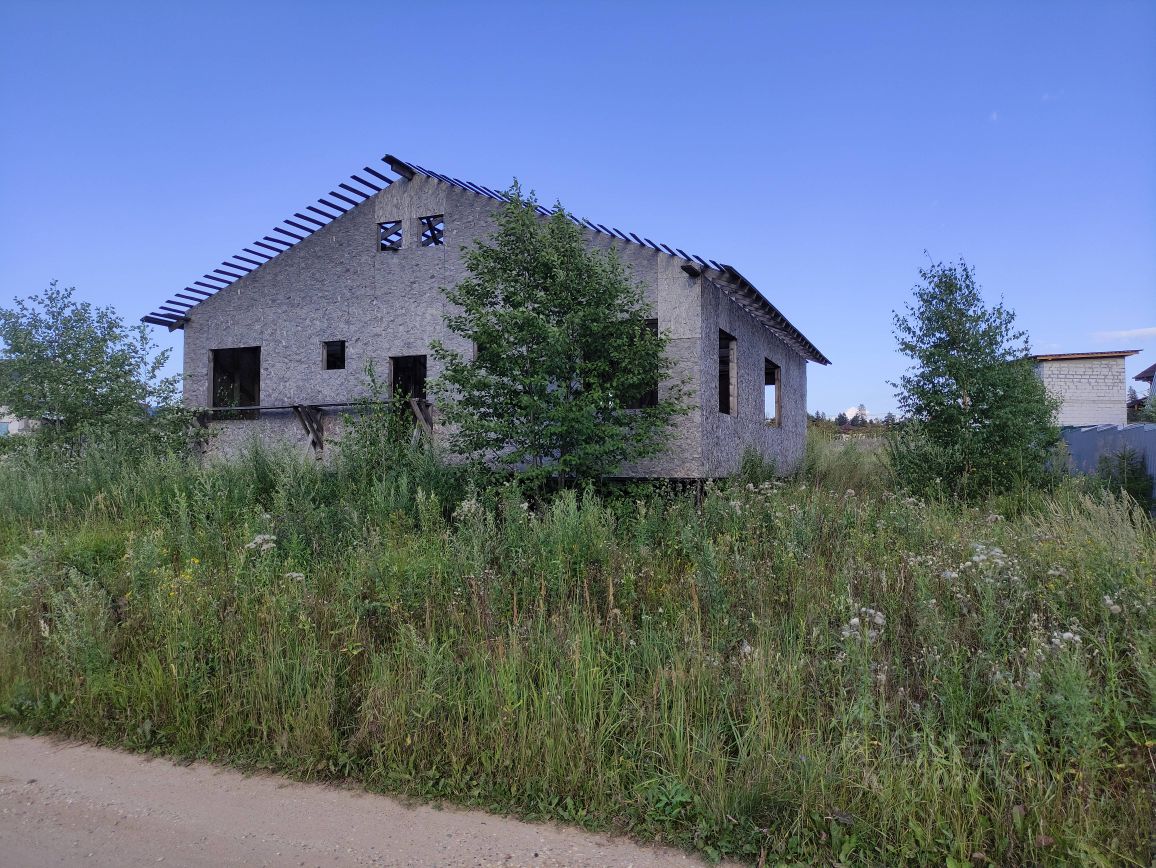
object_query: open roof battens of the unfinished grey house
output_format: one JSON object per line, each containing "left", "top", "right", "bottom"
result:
{"left": 141, "top": 154, "right": 830, "bottom": 365}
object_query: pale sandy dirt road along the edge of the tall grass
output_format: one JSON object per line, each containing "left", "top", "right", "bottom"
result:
{"left": 0, "top": 734, "right": 721, "bottom": 868}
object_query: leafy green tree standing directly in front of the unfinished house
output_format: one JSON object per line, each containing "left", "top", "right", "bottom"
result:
{"left": 434, "top": 183, "right": 687, "bottom": 483}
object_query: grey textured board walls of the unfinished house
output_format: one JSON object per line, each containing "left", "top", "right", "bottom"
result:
{"left": 185, "top": 176, "right": 807, "bottom": 477}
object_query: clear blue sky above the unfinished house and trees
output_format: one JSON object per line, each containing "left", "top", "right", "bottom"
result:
{"left": 0, "top": 0, "right": 1156, "bottom": 414}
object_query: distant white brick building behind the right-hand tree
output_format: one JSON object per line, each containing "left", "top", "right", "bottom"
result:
{"left": 1031, "top": 349, "right": 1137, "bottom": 428}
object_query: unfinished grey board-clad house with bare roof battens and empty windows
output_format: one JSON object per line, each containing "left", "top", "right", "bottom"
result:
{"left": 143, "top": 156, "right": 829, "bottom": 478}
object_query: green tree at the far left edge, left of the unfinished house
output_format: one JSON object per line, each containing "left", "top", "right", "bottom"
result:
{"left": 0, "top": 281, "right": 191, "bottom": 442}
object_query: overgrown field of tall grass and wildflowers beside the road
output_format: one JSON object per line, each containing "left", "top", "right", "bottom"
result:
{"left": 0, "top": 432, "right": 1156, "bottom": 865}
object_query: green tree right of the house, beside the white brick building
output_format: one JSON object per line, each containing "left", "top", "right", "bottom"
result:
{"left": 891, "top": 260, "right": 1059, "bottom": 497}
